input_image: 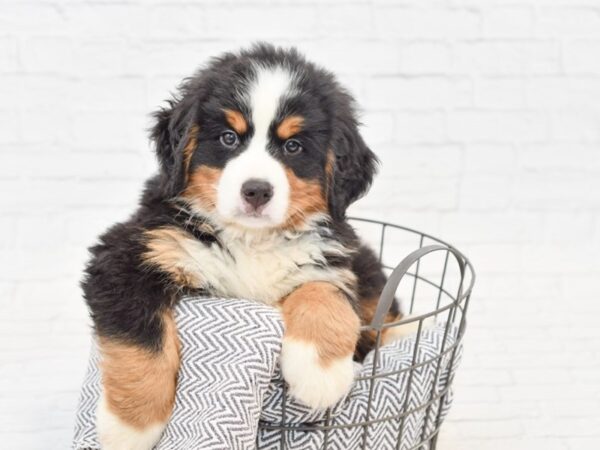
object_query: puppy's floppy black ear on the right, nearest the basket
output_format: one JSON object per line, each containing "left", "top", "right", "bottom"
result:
{"left": 329, "top": 109, "right": 379, "bottom": 220}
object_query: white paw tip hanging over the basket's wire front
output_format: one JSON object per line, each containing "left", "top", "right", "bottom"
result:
{"left": 281, "top": 338, "right": 354, "bottom": 409}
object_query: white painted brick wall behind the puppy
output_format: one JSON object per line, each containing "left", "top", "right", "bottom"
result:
{"left": 0, "top": 0, "right": 600, "bottom": 450}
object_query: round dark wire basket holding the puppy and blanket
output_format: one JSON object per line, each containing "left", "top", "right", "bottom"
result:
{"left": 259, "top": 218, "right": 475, "bottom": 450}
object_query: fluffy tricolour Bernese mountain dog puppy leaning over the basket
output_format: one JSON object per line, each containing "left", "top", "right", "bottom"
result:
{"left": 82, "top": 44, "right": 400, "bottom": 449}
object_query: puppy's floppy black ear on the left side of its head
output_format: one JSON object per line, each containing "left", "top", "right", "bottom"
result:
{"left": 150, "top": 99, "right": 192, "bottom": 197}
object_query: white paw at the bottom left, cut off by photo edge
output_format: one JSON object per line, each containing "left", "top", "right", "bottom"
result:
{"left": 96, "top": 397, "right": 166, "bottom": 450}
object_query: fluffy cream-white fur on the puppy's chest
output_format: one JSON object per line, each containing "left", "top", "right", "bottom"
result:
{"left": 185, "top": 234, "right": 339, "bottom": 304}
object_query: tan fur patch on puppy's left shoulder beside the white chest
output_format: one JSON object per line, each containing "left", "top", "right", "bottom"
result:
{"left": 143, "top": 227, "right": 202, "bottom": 288}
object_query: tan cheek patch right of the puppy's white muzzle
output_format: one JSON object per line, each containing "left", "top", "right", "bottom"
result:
{"left": 284, "top": 169, "right": 327, "bottom": 228}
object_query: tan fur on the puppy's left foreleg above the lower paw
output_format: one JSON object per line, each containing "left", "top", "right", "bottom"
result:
{"left": 99, "top": 312, "right": 180, "bottom": 429}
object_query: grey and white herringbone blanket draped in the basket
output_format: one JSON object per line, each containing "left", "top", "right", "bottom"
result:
{"left": 73, "top": 298, "right": 460, "bottom": 450}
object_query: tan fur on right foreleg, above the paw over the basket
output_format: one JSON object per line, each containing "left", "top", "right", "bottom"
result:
{"left": 282, "top": 281, "right": 360, "bottom": 366}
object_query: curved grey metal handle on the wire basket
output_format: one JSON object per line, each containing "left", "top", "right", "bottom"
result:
{"left": 371, "top": 245, "right": 465, "bottom": 329}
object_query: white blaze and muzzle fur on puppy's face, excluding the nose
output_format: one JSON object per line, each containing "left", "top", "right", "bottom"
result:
{"left": 217, "top": 66, "right": 293, "bottom": 227}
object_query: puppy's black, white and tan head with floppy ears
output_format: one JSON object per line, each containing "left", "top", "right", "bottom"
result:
{"left": 152, "top": 45, "right": 376, "bottom": 228}
